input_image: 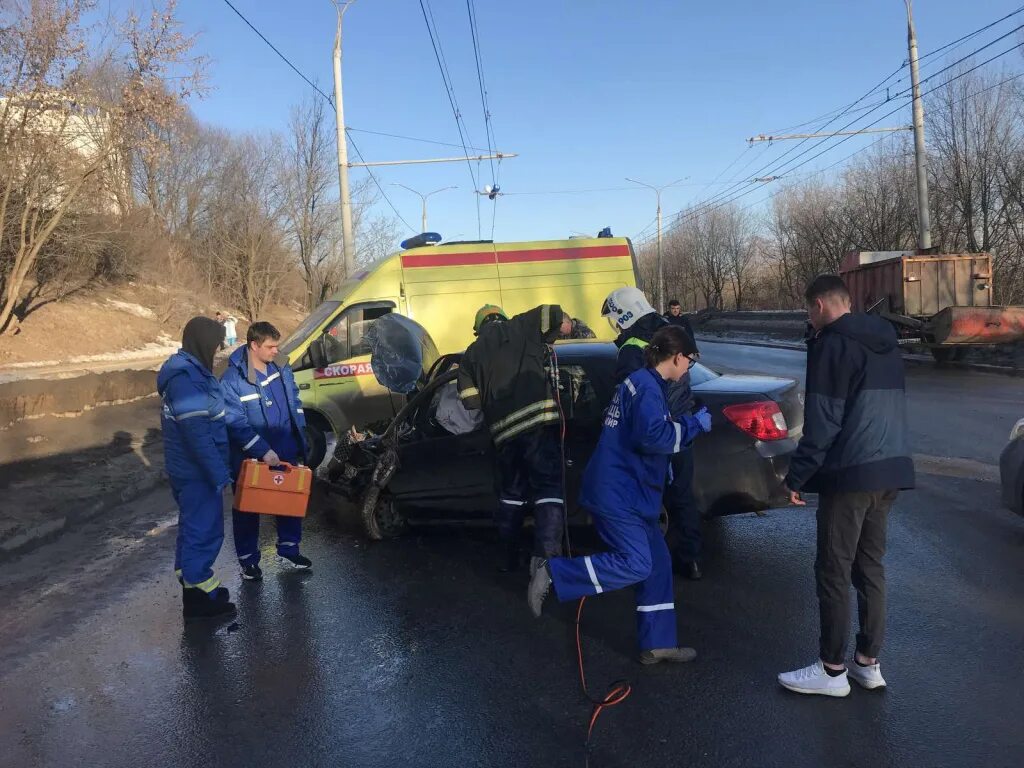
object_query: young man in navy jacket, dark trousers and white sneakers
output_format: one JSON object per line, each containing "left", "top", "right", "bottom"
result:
{"left": 778, "top": 274, "right": 914, "bottom": 696}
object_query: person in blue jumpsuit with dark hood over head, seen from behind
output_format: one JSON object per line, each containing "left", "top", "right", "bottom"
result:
{"left": 157, "top": 317, "right": 234, "bottom": 621}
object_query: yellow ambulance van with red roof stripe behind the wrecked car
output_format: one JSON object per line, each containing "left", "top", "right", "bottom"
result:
{"left": 282, "top": 238, "right": 636, "bottom": 463}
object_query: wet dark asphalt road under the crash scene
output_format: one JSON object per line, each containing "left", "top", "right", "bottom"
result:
{"left": 0, "top": 344, "right": 1024, "bottom": 768}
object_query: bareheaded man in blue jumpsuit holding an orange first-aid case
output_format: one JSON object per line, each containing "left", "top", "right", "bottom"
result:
{"left": 220, "top": 323, "right": 312, "bottom": 581}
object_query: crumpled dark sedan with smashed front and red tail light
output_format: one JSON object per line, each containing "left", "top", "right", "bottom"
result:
{"left": 327, "top": 318, "right": 803, "bottom": 540}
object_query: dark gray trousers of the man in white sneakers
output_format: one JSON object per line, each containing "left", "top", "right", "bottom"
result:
{"left": 814, "top": 490, "right": 898, "bottom": 665}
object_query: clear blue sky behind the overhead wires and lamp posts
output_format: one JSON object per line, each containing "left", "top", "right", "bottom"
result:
{"left": 159, "top": 0, "right": 1024, "bottom": 246}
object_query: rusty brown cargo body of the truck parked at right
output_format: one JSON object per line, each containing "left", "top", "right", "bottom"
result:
{"left": 840, "top": 251, "right": 992, "bottom": 319}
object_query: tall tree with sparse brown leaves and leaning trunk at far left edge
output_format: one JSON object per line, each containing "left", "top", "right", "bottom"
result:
{"left": 0, "top": 0, "right": 200, "bottom": 333}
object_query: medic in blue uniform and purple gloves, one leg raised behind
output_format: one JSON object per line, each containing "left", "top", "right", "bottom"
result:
{"left": 527, "top": 326, "right": 711, "bottom": 664}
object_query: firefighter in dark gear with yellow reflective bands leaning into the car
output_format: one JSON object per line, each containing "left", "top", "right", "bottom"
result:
{"left": 458, "top": 304, "right": 571, "bottom": 572}
